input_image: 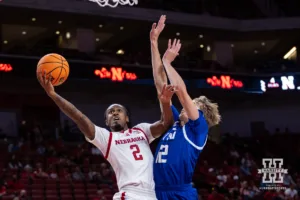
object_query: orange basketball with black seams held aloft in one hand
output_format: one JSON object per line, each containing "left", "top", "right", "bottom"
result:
{"left": 37, "top": 53, "right": 70, "bottom": 86}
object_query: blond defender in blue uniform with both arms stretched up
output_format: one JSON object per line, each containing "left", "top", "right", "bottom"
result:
{"left": 150, "top": 16, "right": 221, "bottom": 200}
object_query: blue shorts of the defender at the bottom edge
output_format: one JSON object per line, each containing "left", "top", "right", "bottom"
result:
{"left": 155, "top": 184, "right": 198, "bottom": 200}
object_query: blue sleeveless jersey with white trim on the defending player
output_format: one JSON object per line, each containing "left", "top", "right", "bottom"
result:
{"left": 153, "top": 106, "right": 208, "bottom": 186}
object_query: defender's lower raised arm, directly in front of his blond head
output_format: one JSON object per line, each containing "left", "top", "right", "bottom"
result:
{"left": 163, "top": 39, "right": 199, "bottom": 120}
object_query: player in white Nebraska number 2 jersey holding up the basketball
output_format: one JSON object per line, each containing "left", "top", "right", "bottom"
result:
{"left": 37, "top": 69, "right": 174, "bottom": 200}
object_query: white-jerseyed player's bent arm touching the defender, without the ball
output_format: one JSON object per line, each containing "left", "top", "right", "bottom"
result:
{"left": 150, "top": 85, "right": 175, "bottom": 138}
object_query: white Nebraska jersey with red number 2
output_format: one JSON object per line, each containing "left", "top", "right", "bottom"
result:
{"left": 87, "top": 123, "right": 155, "bottom": 191}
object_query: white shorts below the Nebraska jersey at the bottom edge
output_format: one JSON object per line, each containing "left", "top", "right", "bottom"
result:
{"left": 113, "top": 187, "right": 157, "bottom": 200}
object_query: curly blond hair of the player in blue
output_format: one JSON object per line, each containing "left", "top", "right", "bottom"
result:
{"left": 193, "top": 96, "right": 221, "bottom": 127}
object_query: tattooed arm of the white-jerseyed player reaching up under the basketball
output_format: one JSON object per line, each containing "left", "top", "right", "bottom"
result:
{"left": 37, "top": 71, "right": 95, "bottom": 140}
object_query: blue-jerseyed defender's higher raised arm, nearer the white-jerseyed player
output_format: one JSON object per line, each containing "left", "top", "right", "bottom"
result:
{"left": 150, "top": 15, "right": 167, "bottom": 94}
